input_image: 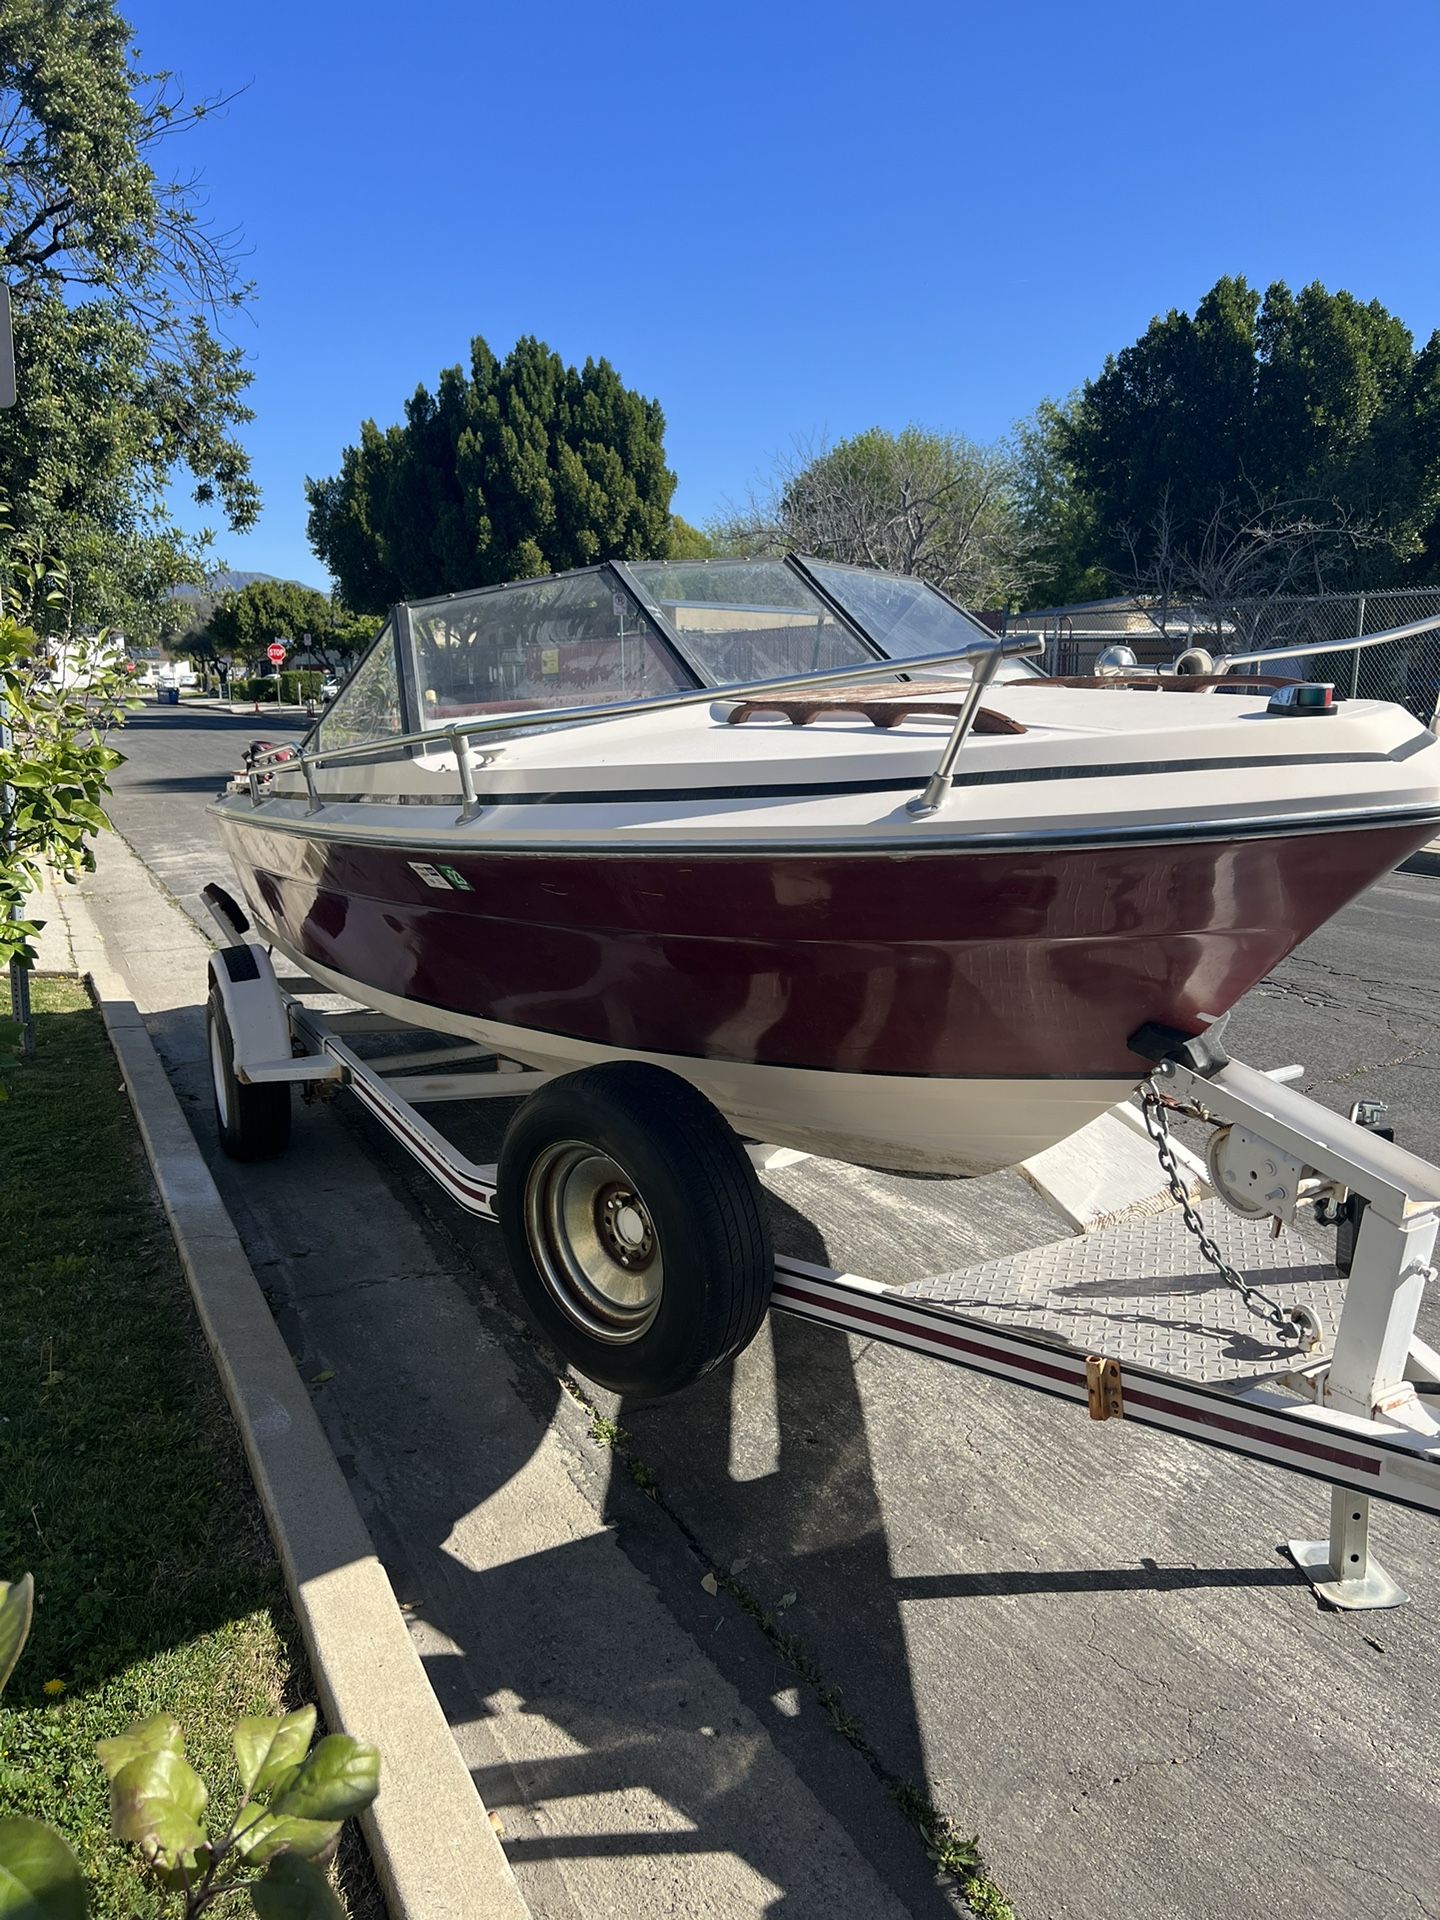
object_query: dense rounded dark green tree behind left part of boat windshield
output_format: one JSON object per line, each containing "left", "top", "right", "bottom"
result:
{"left": 305, "top": 338, "right": 676, "bottom": 612}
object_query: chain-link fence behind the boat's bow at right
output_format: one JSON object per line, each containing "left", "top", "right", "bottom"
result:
{"left": 1002, "top": 588, "right": 1440, "bottom": 726}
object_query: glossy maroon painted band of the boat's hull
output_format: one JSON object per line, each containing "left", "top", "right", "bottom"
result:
{"left": 214, "top": 820, "right": 1432, "bottom": 1079}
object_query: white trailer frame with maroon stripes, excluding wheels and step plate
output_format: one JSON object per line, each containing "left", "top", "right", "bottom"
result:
{"left": 205, "top": 889, "right": 1440, "bottom": 1609}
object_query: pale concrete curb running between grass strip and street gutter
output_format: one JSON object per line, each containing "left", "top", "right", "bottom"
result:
{"left": 65, "top": 895, "right": 530, "bottom": 1920}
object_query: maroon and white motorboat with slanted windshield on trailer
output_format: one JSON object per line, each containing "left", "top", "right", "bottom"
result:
{"left": 213, "top": 555, "right": 1440, "bottom": 1175}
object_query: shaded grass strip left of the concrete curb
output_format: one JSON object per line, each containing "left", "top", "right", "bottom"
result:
{"left": 0, "top": 979, "right": 380, "bottom": 1920}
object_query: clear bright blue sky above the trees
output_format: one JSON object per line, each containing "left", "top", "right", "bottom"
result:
{"left": 121, "top": 0, "right": 1440, "bottom": 586}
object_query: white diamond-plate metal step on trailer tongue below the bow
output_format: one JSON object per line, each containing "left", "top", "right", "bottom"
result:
{"left": 895, "top": 1206, "right": 1346, "bottom": 1386}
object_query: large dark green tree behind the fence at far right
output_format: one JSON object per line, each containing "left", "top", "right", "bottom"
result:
{"left": 1027, "top": 278, "right": 1440, "bottom": 597}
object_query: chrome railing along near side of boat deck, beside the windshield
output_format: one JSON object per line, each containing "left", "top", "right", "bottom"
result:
{"left": 248, "top": 634, "right": 1043, "bottom": 820}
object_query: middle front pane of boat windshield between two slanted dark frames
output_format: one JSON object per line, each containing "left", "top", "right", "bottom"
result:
{"left": 626, "top": 561, "right": 876, "bottom": 687}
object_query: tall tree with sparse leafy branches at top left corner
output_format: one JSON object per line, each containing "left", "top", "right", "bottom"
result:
{"left": 0, "top": 0, "right": 259, "bottom": 637}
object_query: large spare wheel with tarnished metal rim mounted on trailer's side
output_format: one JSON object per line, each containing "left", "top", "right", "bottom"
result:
{"left": 497, "top": 1062, "right": 774, "bottom": 1396}
